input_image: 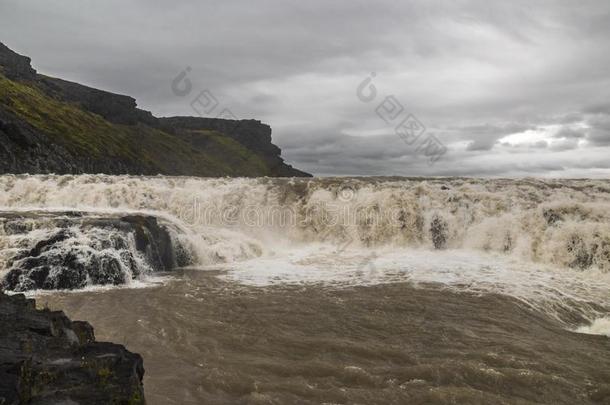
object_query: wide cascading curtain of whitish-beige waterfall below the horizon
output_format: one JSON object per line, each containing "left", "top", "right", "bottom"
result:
{"left": 0, "top": 175, "right": 610, "bottom": 271}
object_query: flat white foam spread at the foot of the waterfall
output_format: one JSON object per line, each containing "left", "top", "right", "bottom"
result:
{"left": 215, "top": 244, "right": 610, "bottom": 319}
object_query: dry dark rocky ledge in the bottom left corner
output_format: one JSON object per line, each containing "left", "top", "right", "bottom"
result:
{"left": 0, "top": 292, "right": 145, "bottom": 405}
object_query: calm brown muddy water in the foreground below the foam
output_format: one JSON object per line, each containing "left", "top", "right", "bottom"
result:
{"left": 37, "top": 270, "right": 610, "bottom": 405}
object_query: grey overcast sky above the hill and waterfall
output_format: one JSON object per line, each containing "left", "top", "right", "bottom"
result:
{"left": 0, "top": 0, "right": 610, "bottom": 177}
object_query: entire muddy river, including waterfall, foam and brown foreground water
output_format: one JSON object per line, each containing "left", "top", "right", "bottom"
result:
{"left": 0, "top": 175, "right": 610, "bottom": 405}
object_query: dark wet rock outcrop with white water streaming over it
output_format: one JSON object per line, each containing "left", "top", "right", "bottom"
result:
{"left": 0, "top": 212, "right": 190, "bottom": 291}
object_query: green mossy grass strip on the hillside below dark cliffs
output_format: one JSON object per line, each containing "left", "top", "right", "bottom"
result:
{"left": 0, "top": 72, "right": 270, "bottom": 176}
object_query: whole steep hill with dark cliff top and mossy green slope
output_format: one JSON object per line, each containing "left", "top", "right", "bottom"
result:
{"left": 0, "top": 43, "right": 308, "bottom": 177}
